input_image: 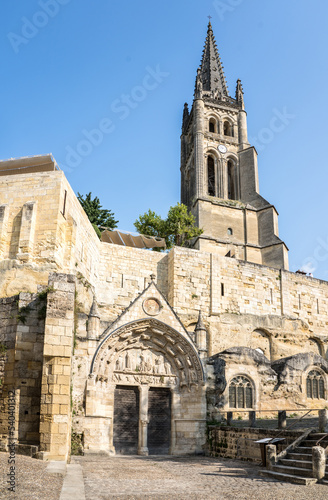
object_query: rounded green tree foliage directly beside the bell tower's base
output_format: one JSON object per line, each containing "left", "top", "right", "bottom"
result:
{"left": 134, "top": 203, "right": 203, "bottom": 248}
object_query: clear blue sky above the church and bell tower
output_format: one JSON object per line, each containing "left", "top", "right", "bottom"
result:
{"left": 0, "top": 0, "right": 328, "bottom": 280}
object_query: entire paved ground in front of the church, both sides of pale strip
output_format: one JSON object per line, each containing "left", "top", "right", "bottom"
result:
{"left": 0, "top": 453, "right": 328, "bottom": 500}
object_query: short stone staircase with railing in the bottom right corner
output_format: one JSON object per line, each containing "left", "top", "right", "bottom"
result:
{"left": 261, "top": 433, "right": 328, "bottom": 485}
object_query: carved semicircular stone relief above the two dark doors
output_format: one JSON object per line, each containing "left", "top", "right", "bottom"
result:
{"left": 92, "top": 319, "right": 203, "bottom": 389}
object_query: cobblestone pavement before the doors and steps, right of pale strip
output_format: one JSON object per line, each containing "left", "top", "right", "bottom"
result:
{"left": 72, "top": 456, "right": 328, "bottom": 500}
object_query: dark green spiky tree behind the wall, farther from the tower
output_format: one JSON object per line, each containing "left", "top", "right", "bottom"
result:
{"left": 77, "top": 192, "right": 118, "bottom": 238}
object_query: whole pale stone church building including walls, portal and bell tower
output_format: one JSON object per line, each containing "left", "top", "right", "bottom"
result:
{"left": 0, "top": 24, "right": 328, "bottom": 460}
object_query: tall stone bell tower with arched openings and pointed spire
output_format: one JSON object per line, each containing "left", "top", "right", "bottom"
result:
{"left": 181, "top": 22, "right": 288, "bottom": 269}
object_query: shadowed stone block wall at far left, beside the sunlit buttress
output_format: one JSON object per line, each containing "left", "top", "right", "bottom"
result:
{"left": 0, "top": 293, "right": 45, "bottom": 444}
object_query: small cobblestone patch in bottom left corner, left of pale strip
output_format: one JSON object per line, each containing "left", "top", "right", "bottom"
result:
{"left": 0, "top": 453, "right": 62, "bottom": 500}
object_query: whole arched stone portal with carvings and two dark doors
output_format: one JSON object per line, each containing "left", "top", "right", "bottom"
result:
{"left": 85, "top": 318, "right": 206, "bottom": 455}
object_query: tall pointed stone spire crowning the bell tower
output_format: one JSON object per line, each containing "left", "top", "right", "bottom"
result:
{"left": 200, "top": 21, "right": 229, "bottom": 96}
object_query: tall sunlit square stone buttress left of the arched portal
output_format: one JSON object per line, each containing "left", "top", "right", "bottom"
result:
{"left": 40, "top": 273, "right": 75, "bottom": 460}
